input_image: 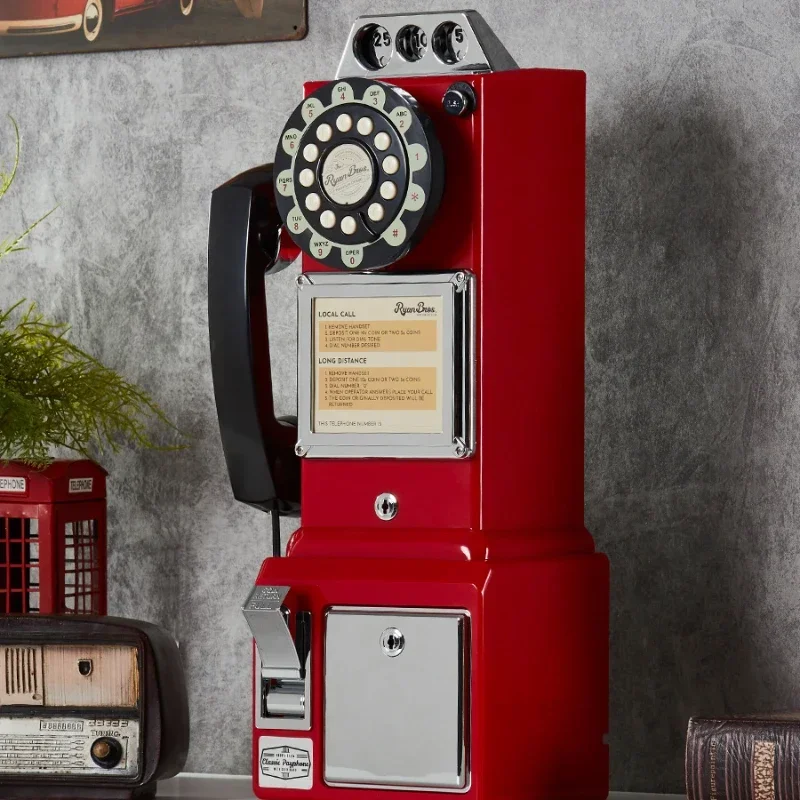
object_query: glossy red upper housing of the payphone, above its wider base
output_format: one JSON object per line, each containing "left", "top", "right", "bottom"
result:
{"left": 302, "top": 70, "right": 585, "bottom": 532}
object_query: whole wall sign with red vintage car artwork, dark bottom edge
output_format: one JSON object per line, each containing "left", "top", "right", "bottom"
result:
{"left": 0, "top": 0, "right": 308, "bottom": 58}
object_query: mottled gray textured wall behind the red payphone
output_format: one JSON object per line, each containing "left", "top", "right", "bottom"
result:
{"left": 0, "top": 0, "right": 800, "bottom": 791}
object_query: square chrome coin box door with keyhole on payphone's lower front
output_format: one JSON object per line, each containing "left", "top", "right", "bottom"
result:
{"left": 324, "top": 607, "right": 469, "bottom": 792}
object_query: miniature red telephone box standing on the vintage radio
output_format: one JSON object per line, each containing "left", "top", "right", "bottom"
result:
{"left": 0, "top": 461, "right": 106, "bottom": 615}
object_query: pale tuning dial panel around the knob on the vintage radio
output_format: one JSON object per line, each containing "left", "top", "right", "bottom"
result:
{"left": 0, "top": 717, "right": 139, "bottom": 778}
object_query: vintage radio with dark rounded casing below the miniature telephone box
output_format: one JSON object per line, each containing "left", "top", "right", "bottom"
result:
{"left": 0, "top": 616, "right": 189, "bottom": 800}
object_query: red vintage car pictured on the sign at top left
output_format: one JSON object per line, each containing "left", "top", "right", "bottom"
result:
{"left": 0, "top": 0, "right": 195, "bottom": 42}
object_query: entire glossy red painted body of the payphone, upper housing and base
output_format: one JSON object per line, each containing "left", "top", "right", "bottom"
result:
{"left": 254, "top": 70, "right": 609, "bottom": 800}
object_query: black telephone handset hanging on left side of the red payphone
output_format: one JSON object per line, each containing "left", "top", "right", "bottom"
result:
{"left": 208, "top": 164, "right": 300, "bottom": 514}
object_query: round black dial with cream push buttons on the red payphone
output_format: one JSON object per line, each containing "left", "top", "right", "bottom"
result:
{"left": 275, "top": 78, "right": 443, "bottom": 270}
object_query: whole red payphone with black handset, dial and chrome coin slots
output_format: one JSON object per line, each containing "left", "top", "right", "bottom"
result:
{"left": 209, "top": 12, "right": 609, "bottom": 800}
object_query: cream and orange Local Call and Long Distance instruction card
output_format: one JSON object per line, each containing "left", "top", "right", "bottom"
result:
{"left": 313, "top": 296, "right": 444, "bottom": 434}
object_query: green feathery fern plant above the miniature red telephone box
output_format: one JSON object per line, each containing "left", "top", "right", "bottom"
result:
{"left": 0, "top": 119, "right": 183, "bottom": 467}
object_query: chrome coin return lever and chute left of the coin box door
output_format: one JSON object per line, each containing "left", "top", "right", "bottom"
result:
{"left": 242, "top": 586, "right": 311, "bottom": 724}
